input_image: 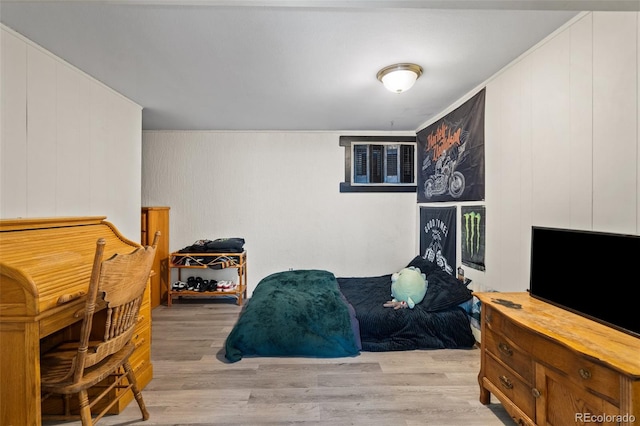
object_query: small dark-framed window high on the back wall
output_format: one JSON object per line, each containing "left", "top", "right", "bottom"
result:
{"left": 340, "top": 136, "right": 416, "bottom": 192}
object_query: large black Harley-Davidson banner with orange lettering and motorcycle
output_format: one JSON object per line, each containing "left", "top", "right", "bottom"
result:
{"left": 417, "top": 89, "right": 485, "bottom": 203}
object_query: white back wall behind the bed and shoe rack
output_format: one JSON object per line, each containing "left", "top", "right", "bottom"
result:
{"left": 142, "top": 131, "right": 417, "bottom": 293}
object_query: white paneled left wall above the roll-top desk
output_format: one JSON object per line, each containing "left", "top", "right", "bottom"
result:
{"left": 0, "top": 26, "right": 142, "bottom": 241}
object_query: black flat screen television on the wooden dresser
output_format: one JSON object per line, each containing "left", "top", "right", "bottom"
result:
{"left": 529, "top": 226, "right": 640, "bottom": 338}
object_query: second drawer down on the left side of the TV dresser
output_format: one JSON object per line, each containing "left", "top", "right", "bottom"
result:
{"left": 484, "top": 354, "right": 535, "bottom": 419}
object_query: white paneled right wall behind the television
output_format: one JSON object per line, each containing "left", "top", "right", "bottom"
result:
{"left": 432, "top": 12, "right": 640, "bottom": 291}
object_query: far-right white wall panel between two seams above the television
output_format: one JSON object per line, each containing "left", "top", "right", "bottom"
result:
{"left": 593, "top": 12, "right": 640, "bottom": 233}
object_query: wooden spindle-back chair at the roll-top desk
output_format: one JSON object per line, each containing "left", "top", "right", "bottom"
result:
{"left": 40, "top": 232, "right": 160, "bottom": 426}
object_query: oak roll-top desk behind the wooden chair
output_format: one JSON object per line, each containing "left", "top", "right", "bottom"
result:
{"left": 0, "top": 216, "right": 153, "bottom": 426}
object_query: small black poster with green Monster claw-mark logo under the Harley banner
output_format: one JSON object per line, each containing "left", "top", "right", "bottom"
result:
{"left": 461, "top": 206, "right": 486, "bottom": 271}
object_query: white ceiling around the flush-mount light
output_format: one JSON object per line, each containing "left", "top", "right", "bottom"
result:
{"left": 0, "top": 0, "right": 640, "bottom": 131}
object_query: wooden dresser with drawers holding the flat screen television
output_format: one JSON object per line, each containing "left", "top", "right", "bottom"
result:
{"left": 474, "top": 293, "right": 640, "bottom": 426}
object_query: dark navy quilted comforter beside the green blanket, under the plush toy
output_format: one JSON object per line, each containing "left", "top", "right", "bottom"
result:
{"left": 338, "top": 270, "right": 475, "bottom": 352}
